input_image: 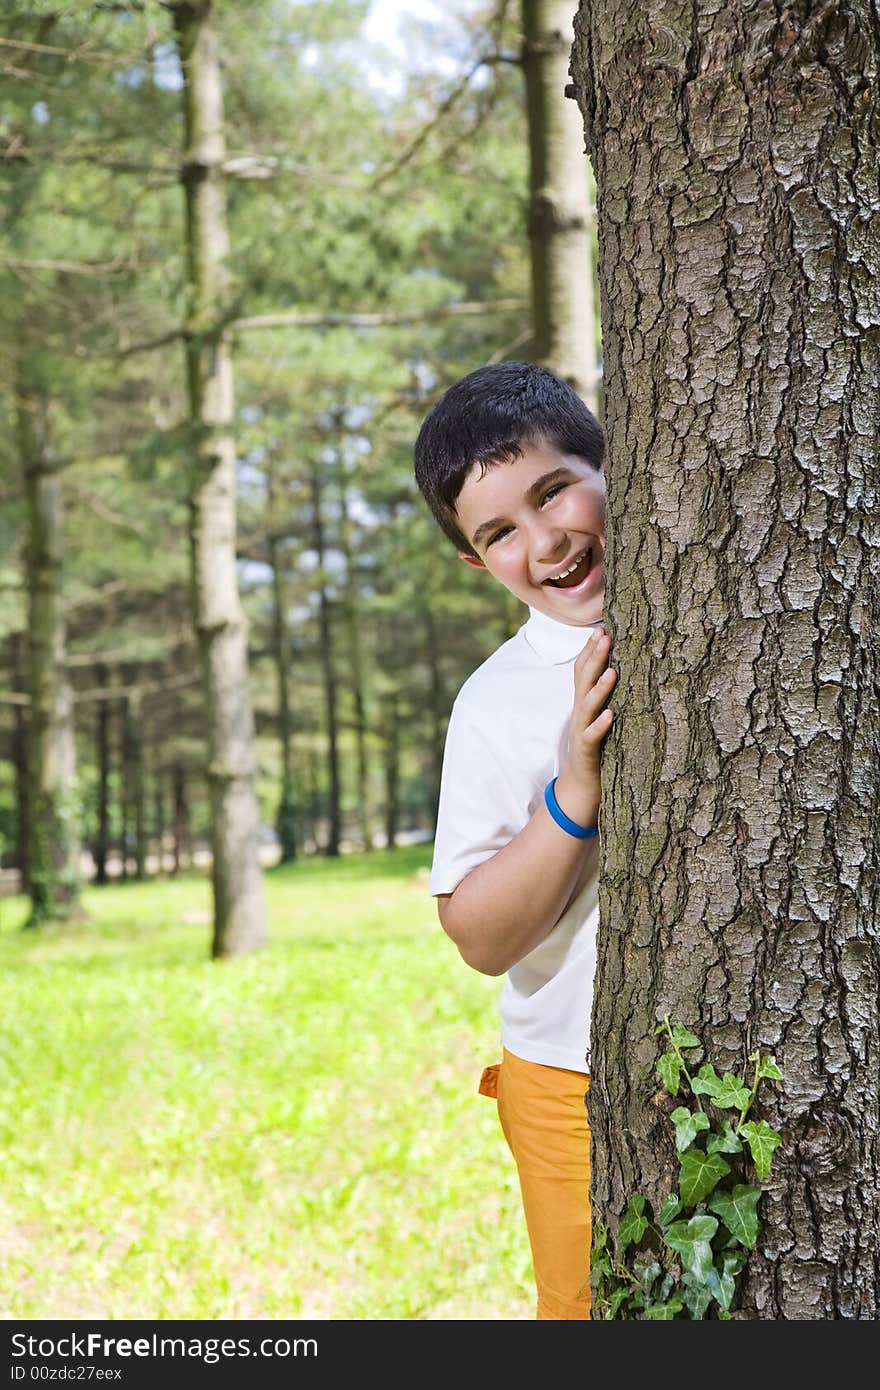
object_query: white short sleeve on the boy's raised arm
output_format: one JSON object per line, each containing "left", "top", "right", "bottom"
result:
{"left": 431, "top": 696, "right": 531, "bottom": 894}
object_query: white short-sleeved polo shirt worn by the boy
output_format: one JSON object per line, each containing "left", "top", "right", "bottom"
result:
{"left": 431, "top": 609, "right": 599, "bottom": 1072}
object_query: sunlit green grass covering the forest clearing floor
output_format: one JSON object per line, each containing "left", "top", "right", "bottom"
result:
{"left": 0, "top": 847, "right": 534, "bottom": 1319}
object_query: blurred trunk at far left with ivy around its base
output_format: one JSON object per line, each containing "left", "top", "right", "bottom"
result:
{"left": 17, "top": 367, "right": 79, "bottom": 927}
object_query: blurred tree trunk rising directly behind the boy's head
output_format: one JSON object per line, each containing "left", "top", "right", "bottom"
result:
{"left": 523, "top": 0, "right": 596, "bottom": 410}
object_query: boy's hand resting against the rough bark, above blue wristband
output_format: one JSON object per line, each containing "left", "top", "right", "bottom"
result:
{"left": 556, "top": 628, "right": 617, "bottom": 826}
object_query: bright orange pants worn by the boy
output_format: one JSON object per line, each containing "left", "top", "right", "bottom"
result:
{"left": 480, "top": 1048, "right": 591, "bottom": 1322}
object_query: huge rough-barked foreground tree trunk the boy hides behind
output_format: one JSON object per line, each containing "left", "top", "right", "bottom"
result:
{"left": 571, "top": 0, "right": 880, "bottom": 1319}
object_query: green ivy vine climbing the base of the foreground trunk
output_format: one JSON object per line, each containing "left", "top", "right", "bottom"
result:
{"left": 591, "top": 1016, "right": 783, "bottom": 1322}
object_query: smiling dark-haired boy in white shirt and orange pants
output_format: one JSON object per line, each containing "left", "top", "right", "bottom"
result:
{"left": 414, "top": 361, "right": 616, "bottom": 1321}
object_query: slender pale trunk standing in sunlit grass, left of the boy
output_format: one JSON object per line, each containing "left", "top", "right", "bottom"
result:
{"left": 171, "top": 0, "right": 267, "bottom": 956}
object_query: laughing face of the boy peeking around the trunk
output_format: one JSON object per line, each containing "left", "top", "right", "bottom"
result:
{"left": 456, "top": 441, "right": 605, "bottom": 627}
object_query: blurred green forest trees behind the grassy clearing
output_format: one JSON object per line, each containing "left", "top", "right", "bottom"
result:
{"left": 0, "top": 0, "right": 561, "bottom": 876}
